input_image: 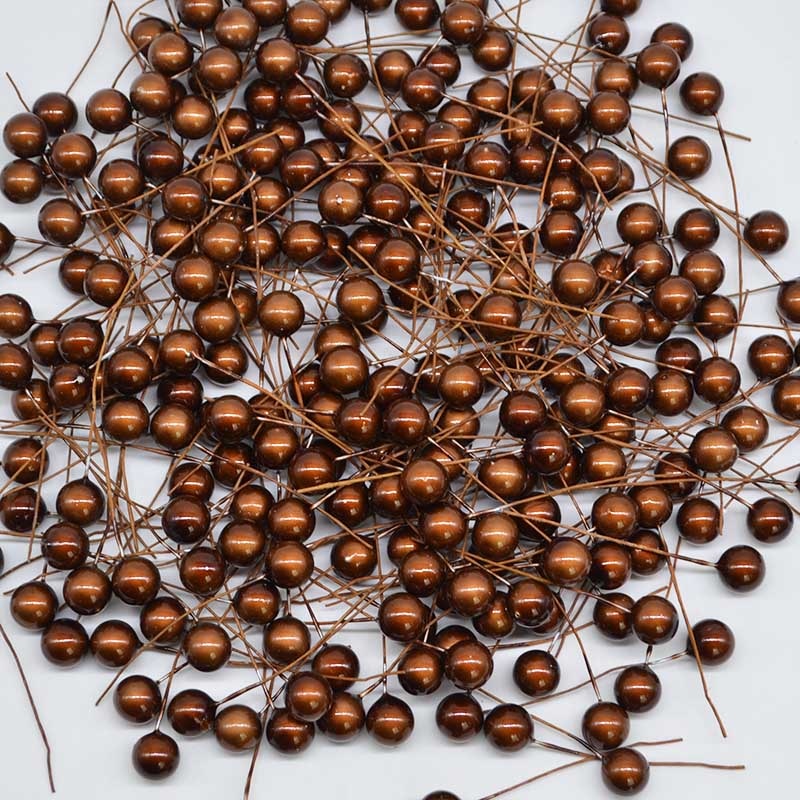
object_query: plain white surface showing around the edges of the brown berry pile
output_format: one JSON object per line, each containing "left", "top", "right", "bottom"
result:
{"left": 0, "top": 0, "right": 800, "bottom": 800}
